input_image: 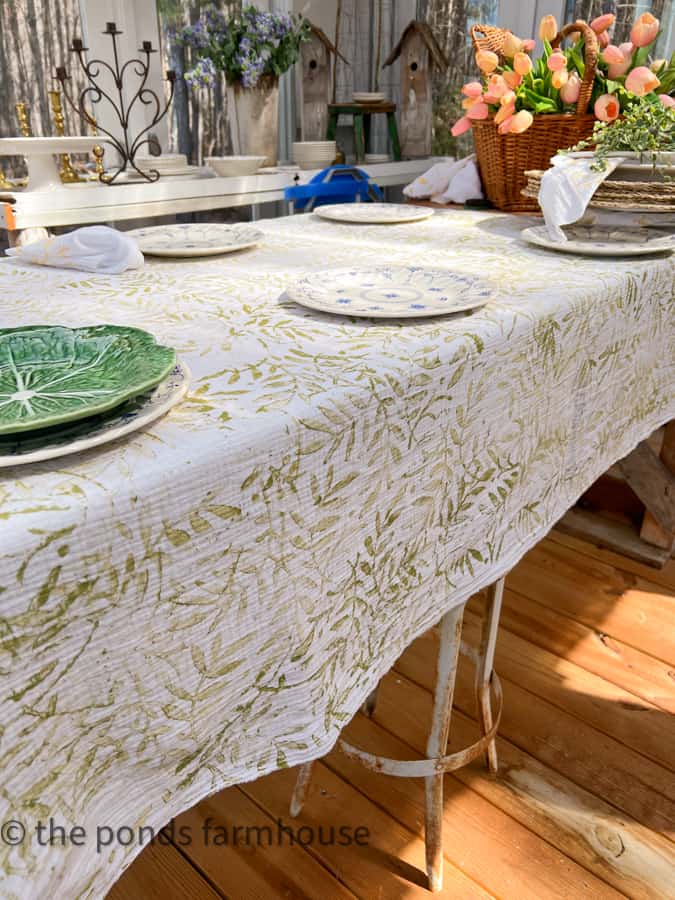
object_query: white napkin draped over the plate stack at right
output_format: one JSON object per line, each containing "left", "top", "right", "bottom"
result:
{"left": 538, "top": 153, "right": 624, "bottom": 242}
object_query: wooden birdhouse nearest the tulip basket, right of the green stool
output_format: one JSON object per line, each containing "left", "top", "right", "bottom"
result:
{"left": 383, "top": 21, "right": 448, "bottom": 157}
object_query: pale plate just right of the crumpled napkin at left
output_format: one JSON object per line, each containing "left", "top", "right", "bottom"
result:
{"left": 126, "top": 222, "right": 263, "bottom": 257}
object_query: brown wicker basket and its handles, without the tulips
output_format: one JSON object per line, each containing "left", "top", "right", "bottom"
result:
{"left": 471, "top": 21, "right": 598, "bottom": 212}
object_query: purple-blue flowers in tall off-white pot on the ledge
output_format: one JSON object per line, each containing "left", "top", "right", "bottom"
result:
{"left": 177, "top": 5, "right": 309, "bottom": 165}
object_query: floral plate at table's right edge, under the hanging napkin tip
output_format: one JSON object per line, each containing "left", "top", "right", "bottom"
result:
{"left": 521, "top": 225, "right": 675, "bottom": 256}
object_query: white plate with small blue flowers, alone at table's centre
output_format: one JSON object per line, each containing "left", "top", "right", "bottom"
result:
{"left": 286, "top": 266, "right": 495, "bottom": 319}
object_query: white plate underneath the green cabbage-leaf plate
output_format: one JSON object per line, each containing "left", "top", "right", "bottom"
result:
{"left": 0, "top": 360, "right": 190, "bottom": 469}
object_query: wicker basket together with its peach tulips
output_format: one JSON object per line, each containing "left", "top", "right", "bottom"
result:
{"left": 452, "top": 13, "right": 675, "bottom": 210}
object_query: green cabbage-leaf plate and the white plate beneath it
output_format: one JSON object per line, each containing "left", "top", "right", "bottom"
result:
{"left": 0, "top": 325, "right": 189, "bottom": 466}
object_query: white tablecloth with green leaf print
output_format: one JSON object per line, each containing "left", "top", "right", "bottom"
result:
{"left": 0, "top": 212, "right": 675, "bottom": 900}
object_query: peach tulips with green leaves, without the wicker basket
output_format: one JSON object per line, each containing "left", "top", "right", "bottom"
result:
{"left": 452, "top": 12, "right": 675, "bottom": 137}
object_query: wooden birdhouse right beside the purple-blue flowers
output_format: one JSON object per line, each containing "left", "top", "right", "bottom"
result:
{"left": 299, "top": 25, "right": 348, "bottom": 141}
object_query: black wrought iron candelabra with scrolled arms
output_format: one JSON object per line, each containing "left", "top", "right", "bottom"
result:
{"left": 56, "top": 22, "right": 176, "bottom": 184}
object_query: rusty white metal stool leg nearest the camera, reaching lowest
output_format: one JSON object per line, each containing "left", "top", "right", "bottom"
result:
{"left": 425, "top": 605, "right": 464, "bottom": 891}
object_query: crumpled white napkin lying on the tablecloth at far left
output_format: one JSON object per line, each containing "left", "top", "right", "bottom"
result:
{"left": 6, "top": 225, "right": 143, "bottom": 275}
